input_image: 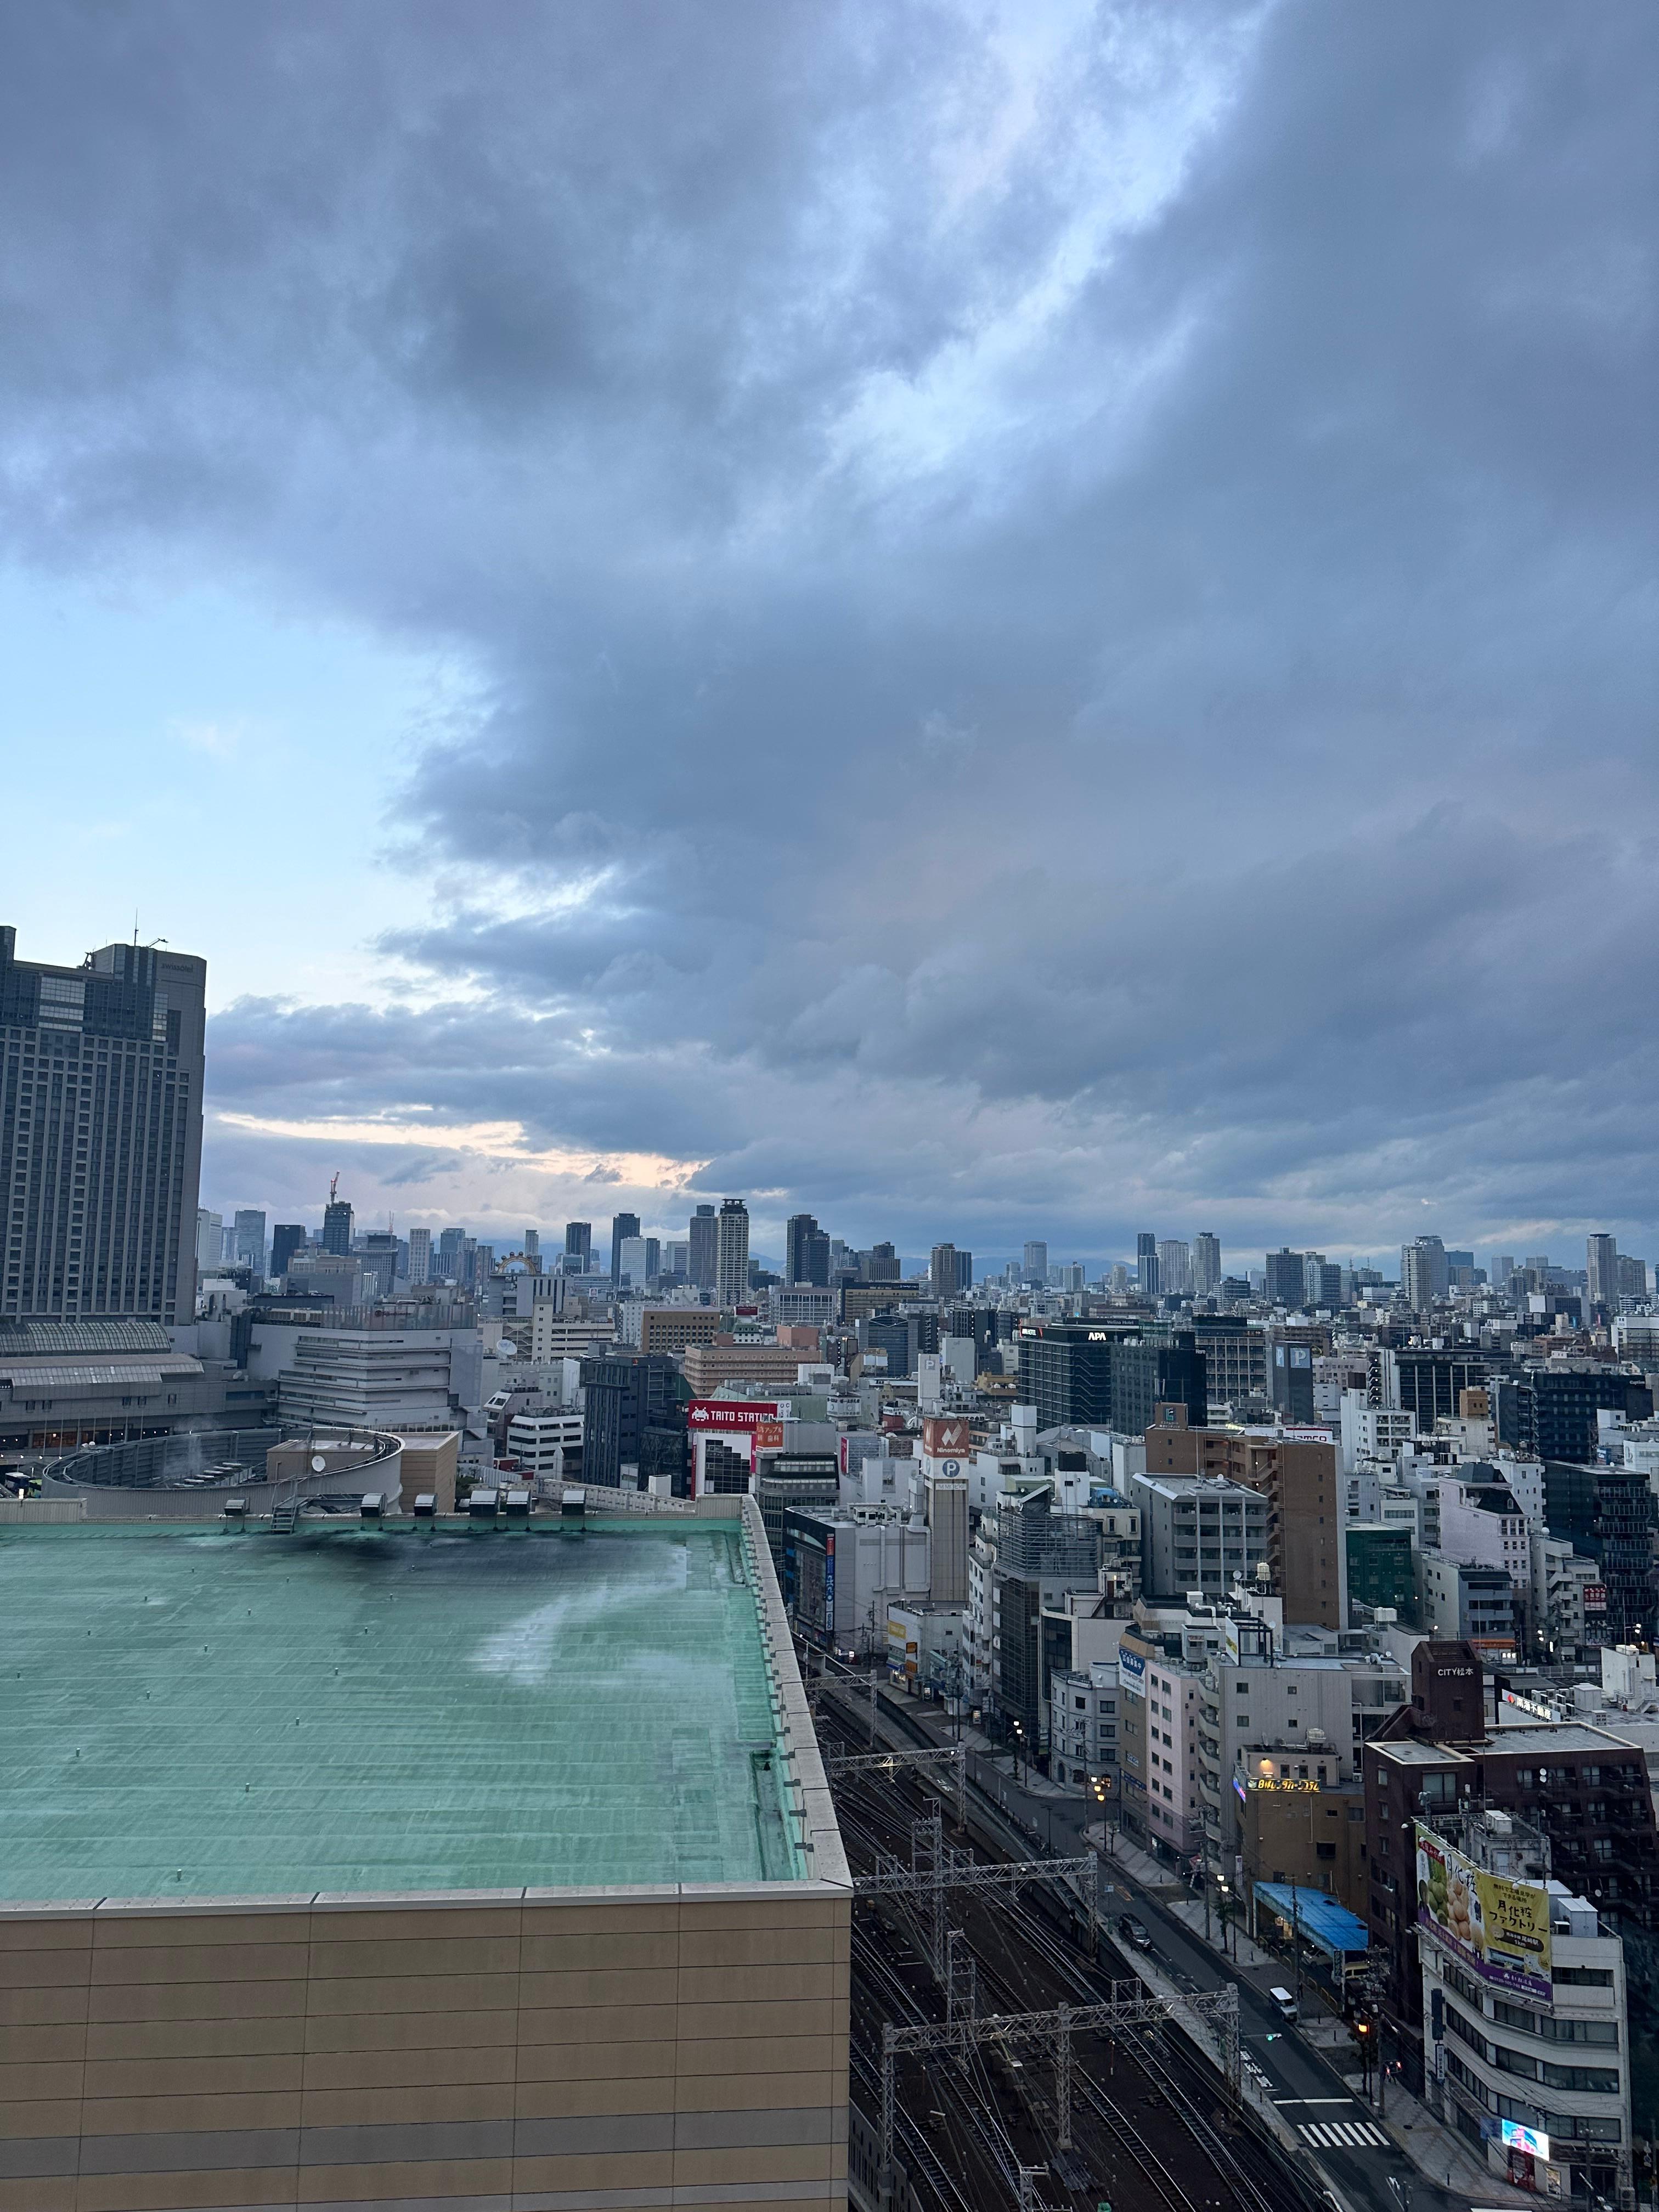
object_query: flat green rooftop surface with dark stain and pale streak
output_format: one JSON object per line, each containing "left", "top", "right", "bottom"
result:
{"left": 0, "top": 1522, "right": 805, "bottom": 1900}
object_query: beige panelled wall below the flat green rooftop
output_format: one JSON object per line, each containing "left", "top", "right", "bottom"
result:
{"left": 0, "top": 1884, "right": 851, "bottom": 2212}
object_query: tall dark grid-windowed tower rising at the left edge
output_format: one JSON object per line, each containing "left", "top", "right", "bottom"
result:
{"left": 0, "top": 927, "right": 208, "bottom": 1325}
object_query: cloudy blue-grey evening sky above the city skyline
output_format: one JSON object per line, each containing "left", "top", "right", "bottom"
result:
{"left": 0, "top": 0, "right": 1659, "bottom": 1263}
